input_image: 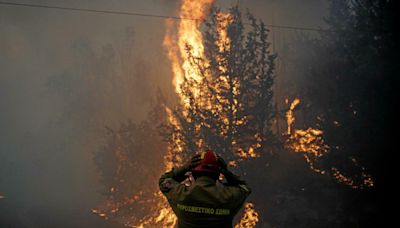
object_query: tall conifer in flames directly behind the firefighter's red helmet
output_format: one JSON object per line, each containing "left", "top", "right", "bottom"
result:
{"left": 165, "top": 6, "right": 276, "bottom": 160}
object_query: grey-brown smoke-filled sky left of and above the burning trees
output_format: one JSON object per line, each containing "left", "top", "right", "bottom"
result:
{"left": 0, "top": 0, "right": 327, "bottom": 227}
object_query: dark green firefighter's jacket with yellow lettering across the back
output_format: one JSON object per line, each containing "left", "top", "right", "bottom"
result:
{"left": 159, "top": 169, "right": 250, "bottom": 228}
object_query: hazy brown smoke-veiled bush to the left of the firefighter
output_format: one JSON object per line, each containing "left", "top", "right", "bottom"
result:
{"left": 94, "top": 91, "right": 167, "bottom": 223}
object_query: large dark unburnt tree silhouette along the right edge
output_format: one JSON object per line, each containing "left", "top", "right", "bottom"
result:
{"left": 282, "top": 0, "right": 399, "bottom": 226}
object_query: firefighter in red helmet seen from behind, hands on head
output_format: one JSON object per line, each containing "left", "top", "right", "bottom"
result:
{"left": 159, "top": 150, "right": 251, "bottom": 228}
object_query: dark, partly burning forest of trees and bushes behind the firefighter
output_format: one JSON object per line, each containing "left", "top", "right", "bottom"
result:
{"left": 91, "top": 0, "right": 396, "bottom": 227}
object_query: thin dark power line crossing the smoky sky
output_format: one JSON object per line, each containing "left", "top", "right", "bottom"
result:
{"left": 0, "top": 1, "right": 335, "bottom": 32}
